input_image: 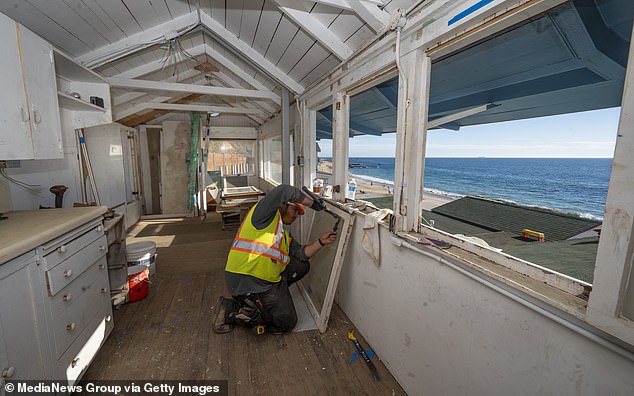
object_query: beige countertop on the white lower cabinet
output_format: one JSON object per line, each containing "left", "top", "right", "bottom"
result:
{"left": 0, "top": 206, "right": 108, "bottom": 264}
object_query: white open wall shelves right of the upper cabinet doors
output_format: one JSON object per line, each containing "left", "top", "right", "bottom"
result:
{"left": 54, "top": 49, "right": 112, "bottom": 129}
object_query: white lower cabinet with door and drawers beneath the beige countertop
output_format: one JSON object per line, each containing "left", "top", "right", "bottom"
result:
{"left": 0, "top": 215, "right": 114, "bottom": 386}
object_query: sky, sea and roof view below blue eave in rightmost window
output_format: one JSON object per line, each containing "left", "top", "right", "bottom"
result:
{"left": 422, "top": 109, "right": 619, "bottom": 283}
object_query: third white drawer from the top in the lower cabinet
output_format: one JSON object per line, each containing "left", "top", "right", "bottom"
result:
{"left": 48, "top": 260, "right": 110, "bottom": 318}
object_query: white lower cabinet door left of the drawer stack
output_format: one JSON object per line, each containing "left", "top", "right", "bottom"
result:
{"left": 0, "top": 252, "right": 47, "bottom": 379}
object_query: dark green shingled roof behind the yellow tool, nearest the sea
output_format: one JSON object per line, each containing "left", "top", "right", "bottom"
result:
{"left": 432, "top": 197, "right": 601, "bottom": 241}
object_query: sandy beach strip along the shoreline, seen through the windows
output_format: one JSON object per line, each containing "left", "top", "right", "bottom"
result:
{"left": 317, "top": 161, "right": 453, "bottom": 210}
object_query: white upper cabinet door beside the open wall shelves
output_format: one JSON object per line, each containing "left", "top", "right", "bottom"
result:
{"left": 20, "top": 25, "right": 64, "bottom": 159}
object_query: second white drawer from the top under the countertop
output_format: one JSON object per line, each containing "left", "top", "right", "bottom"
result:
{"left": 46, "top": 234, "right": 107, "bottom": 296}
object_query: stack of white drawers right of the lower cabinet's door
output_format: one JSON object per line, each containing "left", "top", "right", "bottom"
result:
{"left": 37, "top": 220, "right": 114, "bottom": 384}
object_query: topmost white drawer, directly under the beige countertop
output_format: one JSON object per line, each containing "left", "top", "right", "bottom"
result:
{"left": 42, "top": 221, "right": 107, "bottom": 270}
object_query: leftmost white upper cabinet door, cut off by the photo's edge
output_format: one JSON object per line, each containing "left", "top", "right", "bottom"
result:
{"left": 0, "top": 13, "right": 33, "bottom": 160}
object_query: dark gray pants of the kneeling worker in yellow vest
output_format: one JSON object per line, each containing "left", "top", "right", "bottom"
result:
{"left": 260, "top": 258, "right": 310, "bottom": 333}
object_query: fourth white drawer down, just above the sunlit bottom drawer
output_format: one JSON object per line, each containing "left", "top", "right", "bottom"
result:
{"left": 52, "top": 260, "right": 110, "bottom": 358}
